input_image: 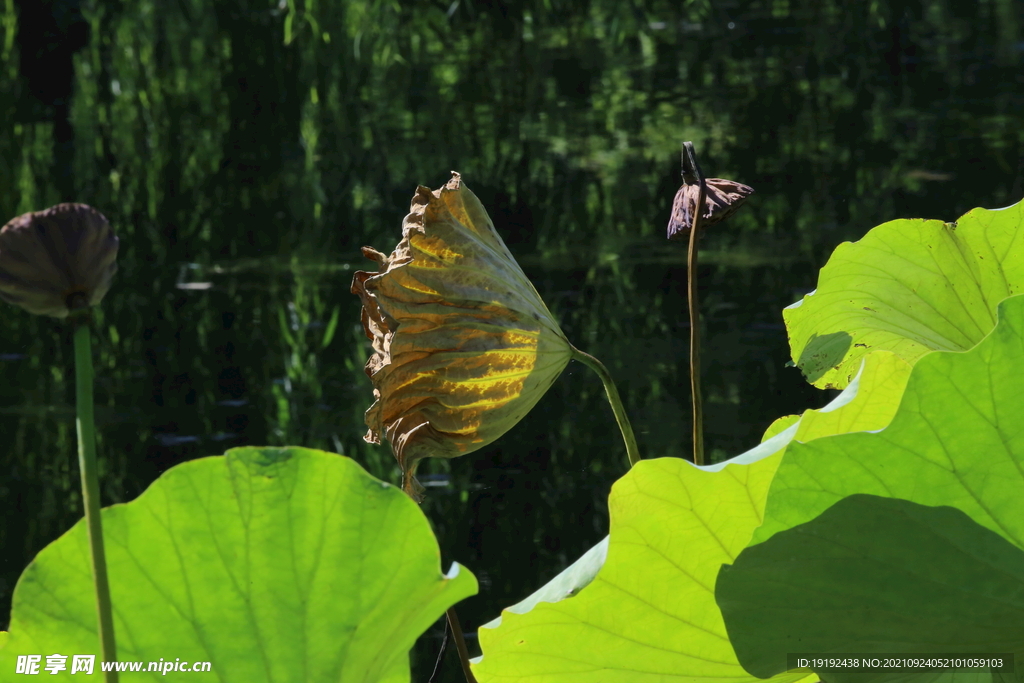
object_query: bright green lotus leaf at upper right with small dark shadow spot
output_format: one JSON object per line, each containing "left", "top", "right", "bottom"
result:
{"left": 783, "top": 203, "right": 1024, "bottom": 388}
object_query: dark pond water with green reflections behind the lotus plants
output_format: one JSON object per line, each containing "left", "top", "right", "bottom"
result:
{"left": 0, "top": 0, "right": 1024, "bottom": 681}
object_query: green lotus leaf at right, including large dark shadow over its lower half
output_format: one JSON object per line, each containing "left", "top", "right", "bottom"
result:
{"left": 719, "top": 296, "right": 1024, "bottom": 680}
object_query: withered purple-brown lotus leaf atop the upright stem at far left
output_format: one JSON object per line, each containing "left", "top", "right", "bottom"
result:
{"left": 0, "top": 204, "right": 118, "bottom": 317}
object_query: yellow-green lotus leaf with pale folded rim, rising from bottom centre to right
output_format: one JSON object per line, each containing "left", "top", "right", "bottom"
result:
{"left": 475, "top": 351, "right": 909, "bottom": 681}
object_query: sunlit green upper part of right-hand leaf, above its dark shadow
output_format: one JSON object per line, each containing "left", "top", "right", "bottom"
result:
{"left": 752, "top": 296, "right": 1024, "bottom": 548}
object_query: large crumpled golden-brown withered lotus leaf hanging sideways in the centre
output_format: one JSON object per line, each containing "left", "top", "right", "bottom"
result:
{"left": 352, "top": 172, "right": 571, "bottom": 498}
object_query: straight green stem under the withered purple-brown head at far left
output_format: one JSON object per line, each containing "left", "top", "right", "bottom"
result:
{"left": 75, "top": 319, "right": 118, "bottom": 683}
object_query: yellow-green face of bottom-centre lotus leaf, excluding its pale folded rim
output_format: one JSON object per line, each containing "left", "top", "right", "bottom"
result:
{"left": 473, "top": 456, "right": 807, "bottom": 683}
